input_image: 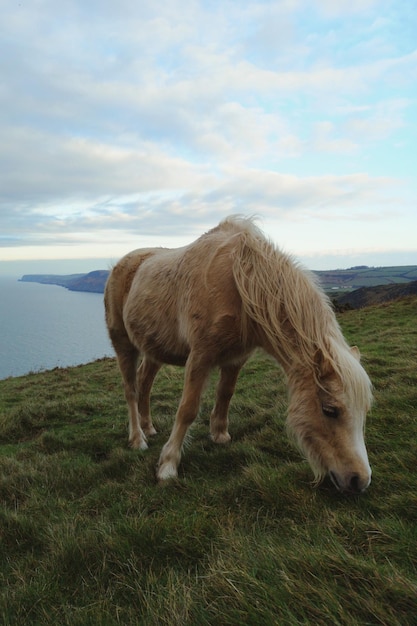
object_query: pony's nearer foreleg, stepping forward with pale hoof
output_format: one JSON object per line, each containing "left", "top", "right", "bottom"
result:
{"left": 156, "top": 363, "right": 209, "bottom": 480}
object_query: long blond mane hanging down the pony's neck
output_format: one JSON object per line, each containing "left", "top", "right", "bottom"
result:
{"left": 218, "top": 216, "right": 371, "bottom": 406}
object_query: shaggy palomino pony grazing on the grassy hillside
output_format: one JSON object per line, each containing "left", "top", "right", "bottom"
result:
{"left": 105, "top": 217, "right": 372, "bottom": 493}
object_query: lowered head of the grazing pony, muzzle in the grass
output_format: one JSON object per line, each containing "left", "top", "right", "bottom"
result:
{"left": 287, "top": 347, "right": 372, "bottom": 494}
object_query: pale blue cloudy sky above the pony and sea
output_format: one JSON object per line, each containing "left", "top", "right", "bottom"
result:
{"left": 0, "top": 0, "right": 417, "bottom": 273}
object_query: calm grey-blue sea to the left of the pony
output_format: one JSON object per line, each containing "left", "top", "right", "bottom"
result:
{"left": 0, "top": 277, "right": 114, "bottom": 379}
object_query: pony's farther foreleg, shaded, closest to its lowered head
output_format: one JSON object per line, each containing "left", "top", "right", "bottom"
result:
{"left": 210, "top": 364, "right": 241, "bottom": 443}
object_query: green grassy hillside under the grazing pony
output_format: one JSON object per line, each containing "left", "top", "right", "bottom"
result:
{"left": 0, "top": 299, "right": 417, "bottom": 626}
